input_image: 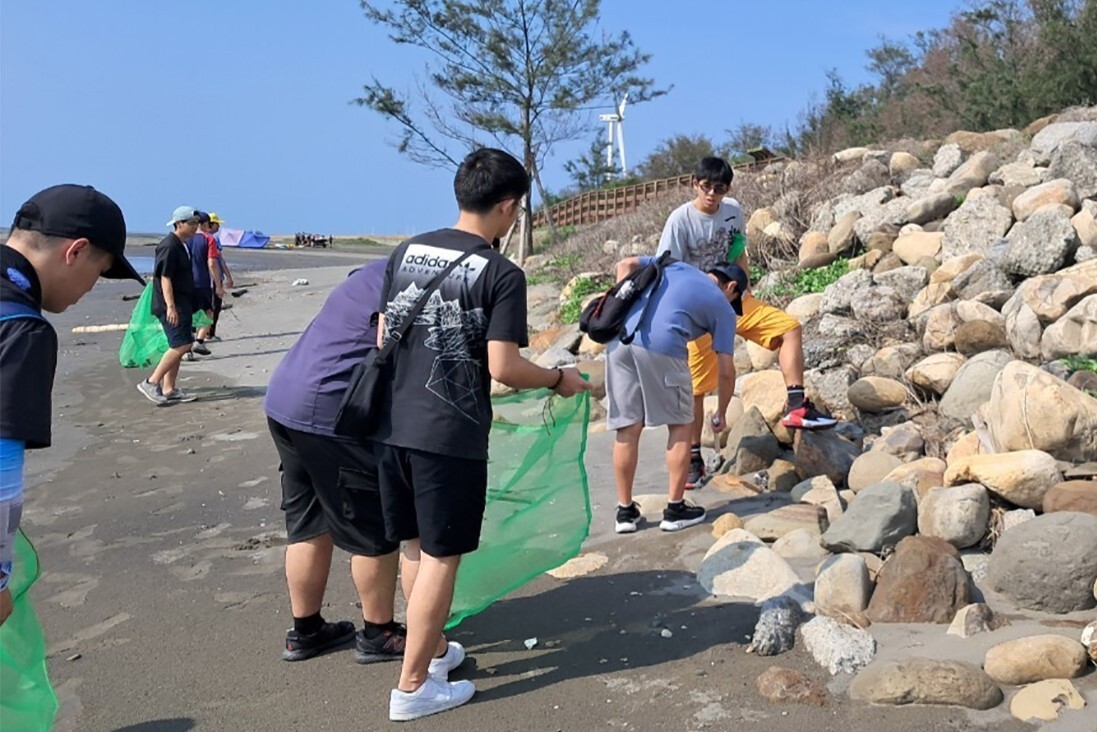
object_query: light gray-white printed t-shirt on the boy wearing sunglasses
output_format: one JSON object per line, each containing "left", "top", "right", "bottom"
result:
{"left": 656, "top": 199, "right": 743, "bottom": 272}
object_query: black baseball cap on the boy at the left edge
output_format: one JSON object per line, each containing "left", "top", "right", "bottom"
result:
{"left": 11, "top": 183, "right": 145, "bottom": 284}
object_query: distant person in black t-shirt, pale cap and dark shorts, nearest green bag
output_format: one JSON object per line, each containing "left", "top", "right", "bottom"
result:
{"left": 137, "top": 206, "right": 199, "bottom": 406}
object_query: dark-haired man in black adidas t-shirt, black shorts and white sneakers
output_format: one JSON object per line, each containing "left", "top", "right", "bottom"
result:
{"left": 365, "top": 149, "right": 590, "bottom": 721}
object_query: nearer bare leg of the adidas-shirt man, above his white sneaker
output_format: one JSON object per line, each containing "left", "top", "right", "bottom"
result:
{"left": 397, "top": 552, "right": 461, "bottom": 692}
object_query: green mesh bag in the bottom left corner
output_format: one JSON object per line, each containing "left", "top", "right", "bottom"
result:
{"left": 0, "top": 529, "right": 57, "bottom": 732}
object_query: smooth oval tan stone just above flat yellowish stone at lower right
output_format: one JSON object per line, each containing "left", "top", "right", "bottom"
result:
{"left": 983, "top": 634, "right": 1088, "bottom": 686}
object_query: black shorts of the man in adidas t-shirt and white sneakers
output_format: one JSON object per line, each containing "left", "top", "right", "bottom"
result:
{"left": 374, "top": 443, "right": 487, "bottom": 556}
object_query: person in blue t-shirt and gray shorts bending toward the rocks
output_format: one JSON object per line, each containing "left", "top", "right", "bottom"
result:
{"left": 606, "top": 257, "right": 747, "bottom": 533}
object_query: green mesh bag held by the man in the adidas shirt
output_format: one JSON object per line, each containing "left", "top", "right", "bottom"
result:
{"left": 446, "top": 390, "right": 590, "bottom": 628}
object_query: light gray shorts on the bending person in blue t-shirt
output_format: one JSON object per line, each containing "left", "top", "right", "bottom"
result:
{"left": 606, "top": 340, "right": 693, "bottom": 429}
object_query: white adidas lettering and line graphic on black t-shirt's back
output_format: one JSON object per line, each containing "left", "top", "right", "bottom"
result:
{"left": 385, "top": 244, "right": 487, "bottom": 425}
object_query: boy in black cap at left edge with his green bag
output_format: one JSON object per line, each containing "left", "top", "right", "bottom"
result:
{"left": 0, "top": 184, "right": 145, "bottom": 732}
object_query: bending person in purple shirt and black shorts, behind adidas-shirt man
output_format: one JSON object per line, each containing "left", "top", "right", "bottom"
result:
{"left": 263, "top": 260, "right": 450, "bottom": 663}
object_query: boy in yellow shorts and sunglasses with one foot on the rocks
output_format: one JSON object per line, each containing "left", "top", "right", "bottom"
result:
{"left": 656, "top": 157, "right": 837, "bottom": 488}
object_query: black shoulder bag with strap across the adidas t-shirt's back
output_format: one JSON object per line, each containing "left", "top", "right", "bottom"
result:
{"left": 336, "top": 249, "right": 476, "bottom": 438}
